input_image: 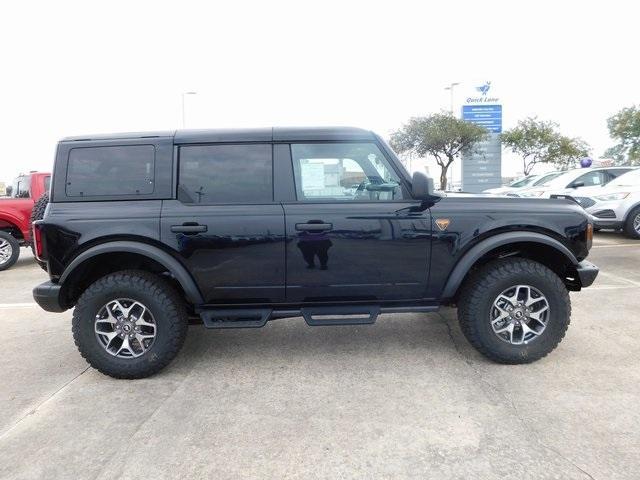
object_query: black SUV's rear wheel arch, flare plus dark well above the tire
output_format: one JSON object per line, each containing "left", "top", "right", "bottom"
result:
{"left": 58, "top": 241, "right": 204, "bottom": 306}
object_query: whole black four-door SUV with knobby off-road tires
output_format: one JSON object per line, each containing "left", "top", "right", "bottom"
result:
{"left": 33, "top": 128, "right": 598, "bottom": 378}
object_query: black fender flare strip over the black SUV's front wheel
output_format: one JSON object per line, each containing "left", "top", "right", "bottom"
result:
{"left": 441, "top": 232, "right": 579, "bottom": 298}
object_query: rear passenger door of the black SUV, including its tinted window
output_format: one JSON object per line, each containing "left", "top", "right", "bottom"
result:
{"left": 161, "top": 143, "right": 285, "bottom": 304}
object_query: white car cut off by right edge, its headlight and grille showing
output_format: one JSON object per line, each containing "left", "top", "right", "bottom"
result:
{"left": 574, "top": 169, "right": 640, "bottom": 239}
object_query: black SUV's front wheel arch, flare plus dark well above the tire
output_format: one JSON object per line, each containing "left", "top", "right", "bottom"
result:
{"left": 441, "top": 232, "right": 580, "bottom": 300}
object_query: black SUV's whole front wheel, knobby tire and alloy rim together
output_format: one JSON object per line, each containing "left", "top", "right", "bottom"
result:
{"left": 458, "top": 258, "right": 571, "bottom": 364}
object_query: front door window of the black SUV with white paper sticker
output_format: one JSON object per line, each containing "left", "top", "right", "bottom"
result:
{"left": 291, "top": 143, "right": 403, "bottom": 201}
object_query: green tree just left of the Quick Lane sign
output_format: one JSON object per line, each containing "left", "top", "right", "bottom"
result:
{"left": 391, "top": 113, "right": 488, "bottom": 190}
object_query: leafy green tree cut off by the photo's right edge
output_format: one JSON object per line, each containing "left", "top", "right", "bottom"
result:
{"left": 605, "top": 105, "right": 640, "bottom": 165}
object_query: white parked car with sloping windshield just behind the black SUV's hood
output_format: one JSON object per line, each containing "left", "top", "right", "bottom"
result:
{"left": 516, "top": 167, "right": 633, "bottom": 198}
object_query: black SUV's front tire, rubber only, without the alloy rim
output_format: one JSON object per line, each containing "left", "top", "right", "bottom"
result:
{"left": 458, "top": 257, "right": 571, "bottom": 364}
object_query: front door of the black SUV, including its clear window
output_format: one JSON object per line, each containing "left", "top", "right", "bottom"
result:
{"left": 283, "top": 143, "right": 431, "bottom": 303}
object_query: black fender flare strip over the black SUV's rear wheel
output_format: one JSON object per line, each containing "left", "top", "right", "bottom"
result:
{"left": 58, "top": 240, "right": 204, "bottom": 305}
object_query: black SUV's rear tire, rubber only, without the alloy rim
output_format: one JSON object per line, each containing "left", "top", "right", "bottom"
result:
{"left": 72, "top": 270, "right": 188, "bottom": 379}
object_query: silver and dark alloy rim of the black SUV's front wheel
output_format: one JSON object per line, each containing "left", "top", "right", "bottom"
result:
{"left": 489, "top": 285, "right": 551, "bottom": 345}
